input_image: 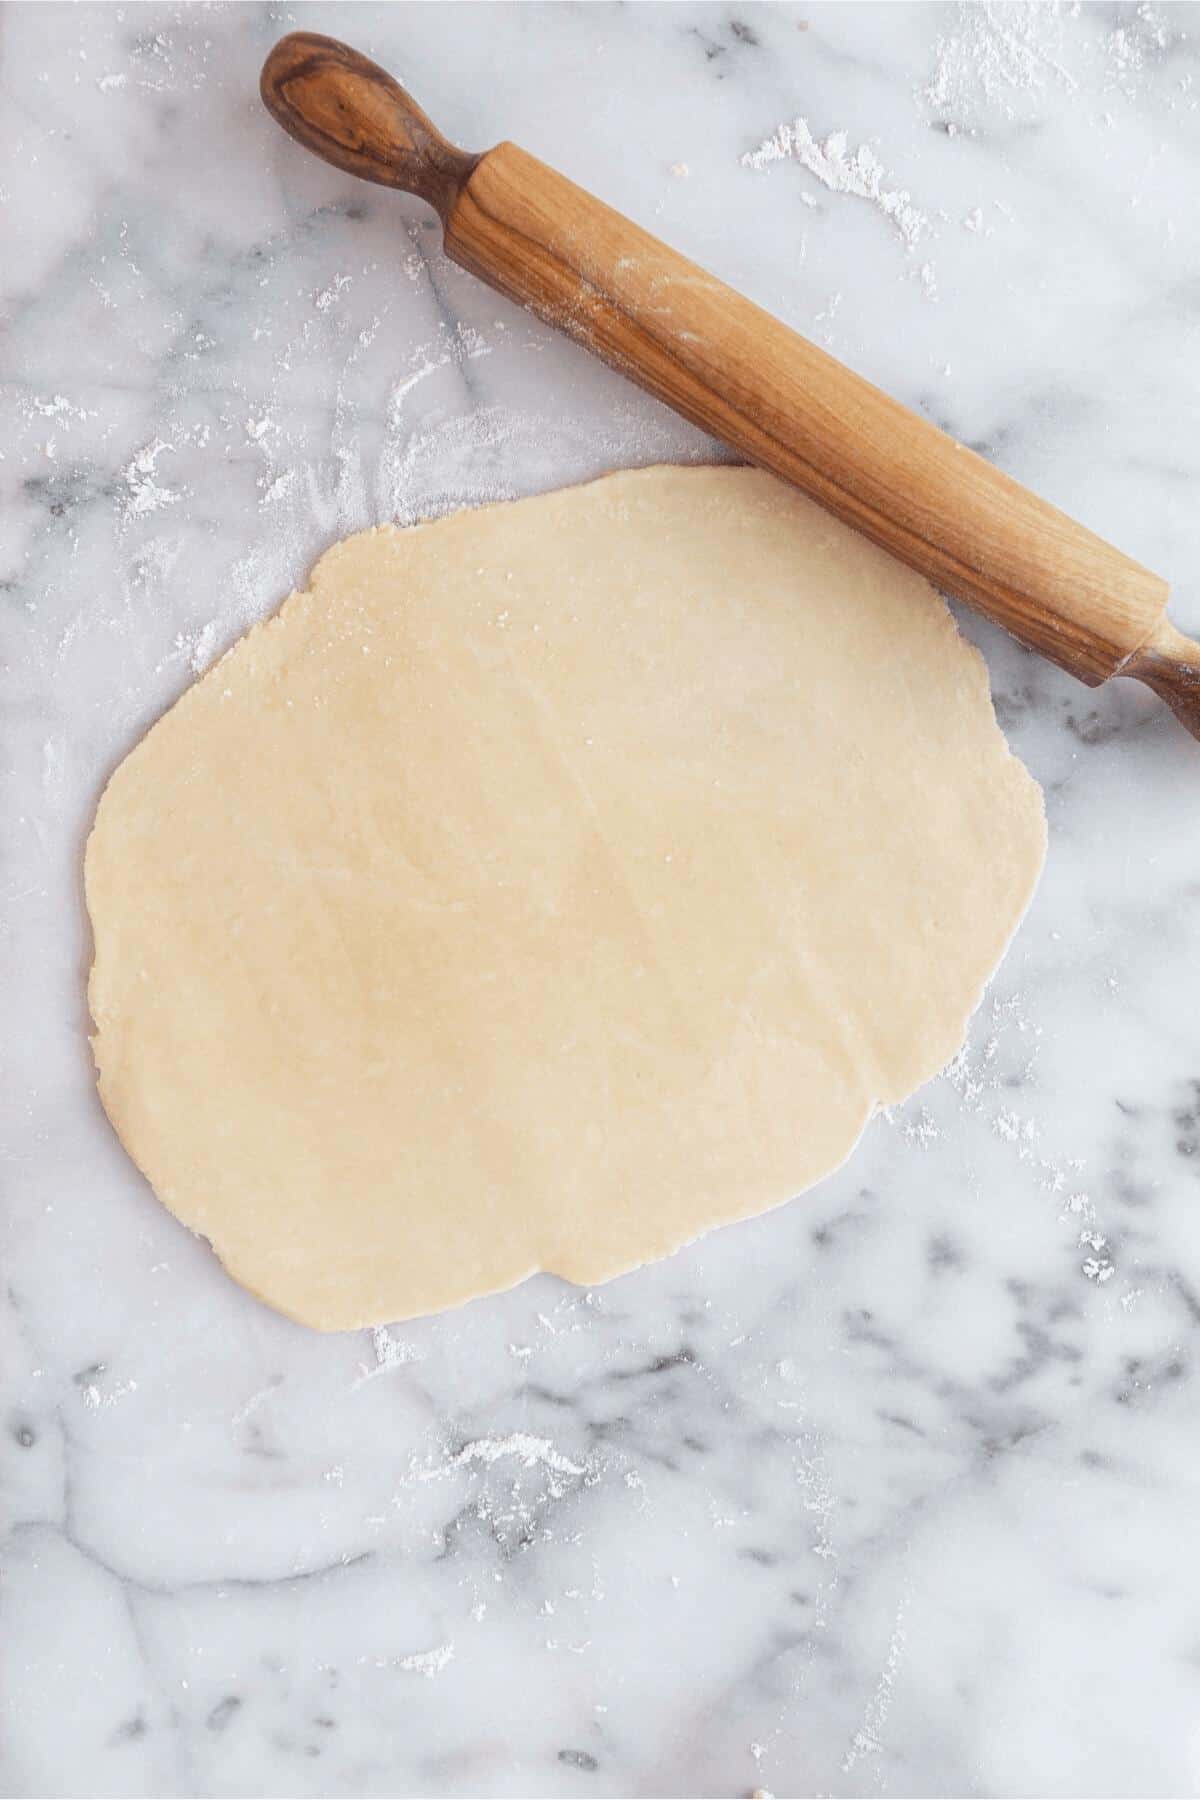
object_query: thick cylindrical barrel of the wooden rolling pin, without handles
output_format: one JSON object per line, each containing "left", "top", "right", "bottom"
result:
{"left": 446, "top": 144, "right": 1168, "bottom": 684}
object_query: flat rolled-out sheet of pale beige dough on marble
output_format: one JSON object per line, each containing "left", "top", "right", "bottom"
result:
{"left": 86, "top": 468, "right": 1045, "bottom": 1330}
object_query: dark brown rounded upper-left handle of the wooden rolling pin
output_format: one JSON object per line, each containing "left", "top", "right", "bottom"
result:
{"left": 259, "top": 31, "right": 479, "bottom": 221}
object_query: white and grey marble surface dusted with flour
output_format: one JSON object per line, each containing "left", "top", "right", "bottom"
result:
{"left": 0, "top": 4, "right": 1200, "bottom": 1796}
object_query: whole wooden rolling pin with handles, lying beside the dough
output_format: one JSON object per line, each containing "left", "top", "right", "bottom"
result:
{"left": 261, "top": 31, "right": 1200, "bottom": 738}
